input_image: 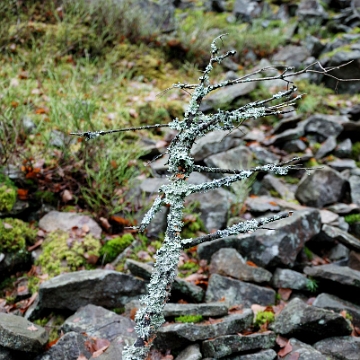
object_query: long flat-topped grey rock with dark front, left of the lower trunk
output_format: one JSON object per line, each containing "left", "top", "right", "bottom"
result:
{"left": 38, "top": 269, "right": 146, "bottom": 311}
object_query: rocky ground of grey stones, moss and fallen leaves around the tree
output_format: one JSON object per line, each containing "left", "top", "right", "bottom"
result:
{"left": 0, "top": 1, "right": 360, "bottom": 360}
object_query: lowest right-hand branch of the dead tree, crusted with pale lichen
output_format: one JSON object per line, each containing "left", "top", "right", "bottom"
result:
{"left": 181, "top": 211, "right": 293, "bottom": 249}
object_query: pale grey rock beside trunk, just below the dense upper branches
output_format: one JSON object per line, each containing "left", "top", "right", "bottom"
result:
{"left": 191, "top": 130, "right": 243, "bottom": 162}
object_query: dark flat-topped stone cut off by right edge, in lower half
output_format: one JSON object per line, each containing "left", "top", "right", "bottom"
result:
{"left": 304, "top": 264, "right": 360, "bottom": 298}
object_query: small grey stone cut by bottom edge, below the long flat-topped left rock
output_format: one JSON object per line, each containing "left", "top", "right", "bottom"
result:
{"left": 35, "top": 331, "right": 92, "bottom": 360}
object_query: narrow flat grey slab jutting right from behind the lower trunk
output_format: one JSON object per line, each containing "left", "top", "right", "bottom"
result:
{"left": 163, "top": 302, "right": 229, "bottom": 317}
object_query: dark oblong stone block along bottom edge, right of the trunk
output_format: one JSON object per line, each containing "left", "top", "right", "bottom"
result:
{"left": 202, "top": 331, "right": 276, "bottom": 359}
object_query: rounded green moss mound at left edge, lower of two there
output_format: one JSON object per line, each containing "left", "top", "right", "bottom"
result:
{"left": 0, "top": 218, "right": 36, "bottom": 253}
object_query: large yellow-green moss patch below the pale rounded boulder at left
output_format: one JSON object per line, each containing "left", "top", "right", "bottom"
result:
{"left": 36, "top": 230, "right": 101, "bottom": 277}
